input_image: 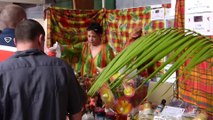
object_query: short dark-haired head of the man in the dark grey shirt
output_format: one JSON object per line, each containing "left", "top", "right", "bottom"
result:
{"left": 15, "top": 19, "right": 45, "bottom": 51}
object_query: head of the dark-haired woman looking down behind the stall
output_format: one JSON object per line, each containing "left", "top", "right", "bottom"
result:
{"left": 87, "top": 22, "right": 103, "bottom": 46}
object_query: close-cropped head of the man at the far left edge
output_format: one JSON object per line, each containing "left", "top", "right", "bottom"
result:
{"left": 0, "top": 4, "right": 27, "bottom": 28}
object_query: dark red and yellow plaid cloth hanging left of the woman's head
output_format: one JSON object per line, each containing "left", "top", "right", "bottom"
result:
{"left": 45, "top": 7, "right": 104, "bottom": 47}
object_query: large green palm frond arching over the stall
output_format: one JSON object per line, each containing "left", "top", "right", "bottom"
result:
{"left": 88, "top": 28, "right": 213, "bottom": 101}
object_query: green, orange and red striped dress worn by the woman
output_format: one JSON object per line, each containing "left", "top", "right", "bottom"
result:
{"left": 74, "top": 42, "right": 114, "bottom": 77}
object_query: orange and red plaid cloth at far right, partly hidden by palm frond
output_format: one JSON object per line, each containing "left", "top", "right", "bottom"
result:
{"left": 175, "top": 0, "right": 213, "bottom": 117}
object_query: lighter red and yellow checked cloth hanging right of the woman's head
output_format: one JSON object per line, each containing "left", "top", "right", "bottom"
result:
{"left": 105, "top": 6, "right": 169, "bottom": 52}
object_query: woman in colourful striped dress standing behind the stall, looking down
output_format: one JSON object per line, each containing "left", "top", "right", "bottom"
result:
{"left": 73, "top": 23, "right": 114, "bottom": 78}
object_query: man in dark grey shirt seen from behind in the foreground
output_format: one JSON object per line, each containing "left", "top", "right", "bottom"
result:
{"left": 0, "top": 20, "right": 86, "bottom": 120}
